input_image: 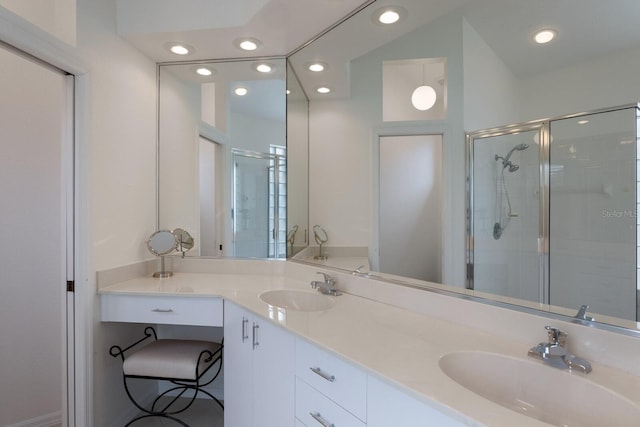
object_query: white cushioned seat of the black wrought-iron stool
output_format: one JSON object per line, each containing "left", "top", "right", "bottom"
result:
{"left": 122, "top": 339, "right": 222, "bottom": 380}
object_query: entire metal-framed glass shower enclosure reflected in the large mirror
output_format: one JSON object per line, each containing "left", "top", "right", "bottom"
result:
{"left": 467, "top": 105, "right": 639, "bottom": 320}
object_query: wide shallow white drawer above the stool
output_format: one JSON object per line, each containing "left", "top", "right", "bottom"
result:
{"left": 100, "top": 294, "right": 223, "bottom": 326}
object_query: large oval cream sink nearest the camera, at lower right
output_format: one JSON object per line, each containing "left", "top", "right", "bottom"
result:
{"left": 440, "top": 351, "right": 640, "bottom": 427}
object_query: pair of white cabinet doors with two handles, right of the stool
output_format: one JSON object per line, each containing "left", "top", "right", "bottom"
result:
{"left": 224, "top": 301, "right": 295, "bottom": 427}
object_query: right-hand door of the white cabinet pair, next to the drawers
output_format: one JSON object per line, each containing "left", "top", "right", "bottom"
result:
{"left": 254, "top": 316, "right": 295, "bottom": 427}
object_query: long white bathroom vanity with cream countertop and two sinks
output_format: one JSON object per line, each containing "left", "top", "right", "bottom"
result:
{"left": 99, "top": 261, "right": 640, "bottom": 427}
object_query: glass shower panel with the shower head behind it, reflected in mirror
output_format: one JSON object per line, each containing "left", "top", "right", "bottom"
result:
{"left": 468, "top": 127, "right": 544, "bottom": 301}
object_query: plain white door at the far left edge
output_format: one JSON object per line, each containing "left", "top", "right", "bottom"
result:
{"left": 0, "top": 46, "right": 73, "bottom": 426}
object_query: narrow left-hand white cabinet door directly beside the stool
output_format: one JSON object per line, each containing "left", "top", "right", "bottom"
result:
{"left": 223, "top": 301, "right": 253, "bottom": 427}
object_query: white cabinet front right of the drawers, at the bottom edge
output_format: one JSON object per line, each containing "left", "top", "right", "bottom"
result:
{"left": 364, "top": 375, "right": 467, "bottom": 427}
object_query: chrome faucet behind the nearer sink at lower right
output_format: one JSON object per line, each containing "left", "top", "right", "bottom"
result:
{"left": 528, "top": 326, "right": 591, "bottom": 374}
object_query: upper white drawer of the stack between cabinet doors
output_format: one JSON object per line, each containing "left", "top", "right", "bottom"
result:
{"left": 296, "top": 339, "right": 367, "bottom": 420}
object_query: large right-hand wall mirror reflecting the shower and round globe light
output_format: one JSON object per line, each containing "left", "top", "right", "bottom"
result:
{"left": 288, "top": 0, "right": 640, "bottom": 331}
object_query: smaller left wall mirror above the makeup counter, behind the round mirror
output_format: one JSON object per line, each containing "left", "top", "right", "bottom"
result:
{"left": 158, "top": 58, "right": 308, "bottom": 259}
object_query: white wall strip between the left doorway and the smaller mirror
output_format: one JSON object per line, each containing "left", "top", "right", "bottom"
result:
{"left": 76, "top": 0, "right": 156, "bottom": 426}
